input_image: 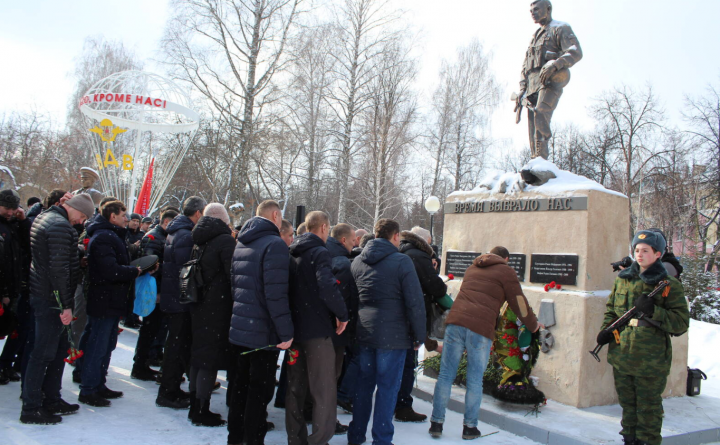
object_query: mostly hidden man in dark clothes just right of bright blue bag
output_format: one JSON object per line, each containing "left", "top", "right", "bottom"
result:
{"left": 130, "top": 210, "right": 178, "bottom": 381}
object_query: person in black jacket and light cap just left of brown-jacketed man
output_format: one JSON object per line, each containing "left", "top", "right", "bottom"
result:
{"left": 395, "top": 227, "right": 447, "bottom": 422}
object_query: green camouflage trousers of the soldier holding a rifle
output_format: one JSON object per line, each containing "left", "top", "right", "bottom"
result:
{"left": 613, "top": 368, "right": 667, "bottom": 445}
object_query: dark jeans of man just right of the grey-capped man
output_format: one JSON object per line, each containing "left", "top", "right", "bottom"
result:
{"left": 80, "top": 316, "right": 120, "bottom": 395}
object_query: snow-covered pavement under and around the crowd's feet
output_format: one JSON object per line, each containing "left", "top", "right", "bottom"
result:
{"left": 0, "top": 329, "right": 537, "bottom": 445}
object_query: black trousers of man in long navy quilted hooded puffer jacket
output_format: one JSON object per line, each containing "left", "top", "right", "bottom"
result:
{"left": 227, "top": 345, "right": 279, "bottom": 445}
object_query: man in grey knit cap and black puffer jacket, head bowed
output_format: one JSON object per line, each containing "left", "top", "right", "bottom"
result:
{"left": 20, "top": 195, "right": 95, "bottom": 424}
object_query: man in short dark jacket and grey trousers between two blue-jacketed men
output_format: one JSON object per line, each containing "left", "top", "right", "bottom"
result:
{"left": 285, "top": 211, "right": 348, "bottom": 445}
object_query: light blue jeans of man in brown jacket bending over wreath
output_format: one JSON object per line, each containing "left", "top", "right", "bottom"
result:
{"left": 430, "top": 324, "right": 492, "bottom": 427}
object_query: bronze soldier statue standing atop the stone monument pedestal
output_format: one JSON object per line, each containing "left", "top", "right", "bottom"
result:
{"left": 513, "top": 0, "right": 582, "bottom": 159}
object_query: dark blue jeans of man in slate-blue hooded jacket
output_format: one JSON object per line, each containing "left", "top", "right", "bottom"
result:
{"left": 348, "top": 346, "right": 407, "bottom": 445}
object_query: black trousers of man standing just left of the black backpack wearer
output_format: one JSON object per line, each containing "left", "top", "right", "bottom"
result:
{"left": 158, "top": 312, "right": 192, "bottom": 397}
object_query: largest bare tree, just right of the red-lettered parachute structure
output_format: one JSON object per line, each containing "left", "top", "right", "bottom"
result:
{"left": 163, "top": 0, "right": 302, "bottom": 205}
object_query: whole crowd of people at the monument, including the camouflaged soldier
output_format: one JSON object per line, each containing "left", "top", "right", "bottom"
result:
{"left": 0, "top": 186, "right": 688, "bottom": 445}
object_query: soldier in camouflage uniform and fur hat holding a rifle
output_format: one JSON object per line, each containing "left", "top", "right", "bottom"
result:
{"left": 597, "top": 230, "right": 690, "bottom": 445}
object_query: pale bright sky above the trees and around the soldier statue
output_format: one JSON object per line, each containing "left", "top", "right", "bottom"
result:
{"left": 0, "top": 0, "right": 720, "bottom": 153}
